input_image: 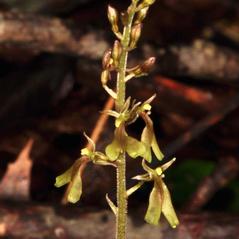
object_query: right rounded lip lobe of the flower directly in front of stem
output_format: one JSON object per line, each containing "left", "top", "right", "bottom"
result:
{"left": 126, "top": 136, "right": 146, "bottom": 158}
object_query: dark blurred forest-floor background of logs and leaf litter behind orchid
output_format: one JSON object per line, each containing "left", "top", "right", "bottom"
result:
{"left": 0, "top": 0, "right": 239, "bottom": 239}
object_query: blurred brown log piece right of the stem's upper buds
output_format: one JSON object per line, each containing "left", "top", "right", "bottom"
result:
{"left": 158, "top": 40, "right": 239, "bottom": 83}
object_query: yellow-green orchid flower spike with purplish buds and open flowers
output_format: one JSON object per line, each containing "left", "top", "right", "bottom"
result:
{"left": 55, "top": 0, "right": 179, "bottom": 234}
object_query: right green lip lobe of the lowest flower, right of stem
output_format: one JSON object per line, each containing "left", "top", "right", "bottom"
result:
{"left": 162, "top": 181, "right": 179, "bottom": 228}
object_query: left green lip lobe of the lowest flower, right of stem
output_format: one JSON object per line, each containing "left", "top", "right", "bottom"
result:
{"left": 144, "top": 186, "right": 162, "bottom": 225}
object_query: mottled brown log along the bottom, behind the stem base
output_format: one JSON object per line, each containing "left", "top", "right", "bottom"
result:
{"left": 0, "top": 202, "right": 239, "bottom": 239}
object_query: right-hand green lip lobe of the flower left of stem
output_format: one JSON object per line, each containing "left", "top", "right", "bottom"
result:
{"left": 67, "top": 170, "right": 82, "bottom": 203}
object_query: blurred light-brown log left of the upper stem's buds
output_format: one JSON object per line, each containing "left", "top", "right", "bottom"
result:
{"left": 0, "top": 12, "right": 108, "bottom": 59}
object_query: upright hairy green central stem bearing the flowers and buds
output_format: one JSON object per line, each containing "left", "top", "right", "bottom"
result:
{"left": 115, "top": 1, "right": 138, "bottom": 239}
